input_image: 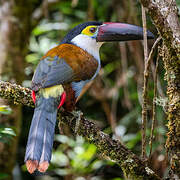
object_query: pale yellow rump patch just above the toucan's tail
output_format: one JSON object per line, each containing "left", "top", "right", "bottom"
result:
{"left": 41, "top": 85, "right": 64, "bottom": 99}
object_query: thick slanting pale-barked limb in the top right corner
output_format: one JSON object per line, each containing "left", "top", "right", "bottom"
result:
{"left": 140, "top": 0, "right": 180, "bottom": 58}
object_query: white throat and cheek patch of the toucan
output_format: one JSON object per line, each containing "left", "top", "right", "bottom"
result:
{"left": 71, "top": 34, "right": 103, "bottom": 60}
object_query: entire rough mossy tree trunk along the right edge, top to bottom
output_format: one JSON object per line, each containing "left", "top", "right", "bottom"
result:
{"left": 141, "top": 0, "right": 180, "bottom": 179}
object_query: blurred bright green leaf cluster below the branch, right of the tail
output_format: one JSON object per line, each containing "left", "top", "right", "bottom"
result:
{"left": 52, "top": 135, "right": 112, "bottom": 180}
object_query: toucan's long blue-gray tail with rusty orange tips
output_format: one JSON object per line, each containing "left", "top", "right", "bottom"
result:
{"left": 25, "top": 97, "right": 58, "bottom": 173}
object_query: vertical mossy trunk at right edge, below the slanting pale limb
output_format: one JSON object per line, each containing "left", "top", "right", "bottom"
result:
{"left": 162, "top": 45, "right": 180, "bottom": 177}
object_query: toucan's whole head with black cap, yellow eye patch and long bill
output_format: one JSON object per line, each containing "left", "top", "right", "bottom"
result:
{"left": 61, "top": 21, "right": 154, "bottom": 58}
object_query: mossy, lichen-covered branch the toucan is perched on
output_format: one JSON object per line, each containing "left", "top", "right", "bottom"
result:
{"left": 0, "top": 81, "right": 160, "bottom": 180}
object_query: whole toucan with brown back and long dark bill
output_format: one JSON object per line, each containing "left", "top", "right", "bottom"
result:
{"left": 25, "top": 22, "right": 154, "bottom": 173}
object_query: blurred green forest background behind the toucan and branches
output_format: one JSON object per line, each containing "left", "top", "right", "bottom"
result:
{"left": 0, "top": 0, "right": 180, "bottom": 180}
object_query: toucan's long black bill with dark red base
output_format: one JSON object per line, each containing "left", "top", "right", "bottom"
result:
{"left": 96, "top": 22, "right": 154, "bottom": 42}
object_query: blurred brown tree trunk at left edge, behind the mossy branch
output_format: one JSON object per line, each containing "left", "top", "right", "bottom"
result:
{"left": 0, "top": 0, "right": 37, "bottom": 179}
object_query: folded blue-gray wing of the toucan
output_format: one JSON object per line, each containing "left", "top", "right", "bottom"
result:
{"left": 32, "top": 56, "right": 75, "bottom": 91}
